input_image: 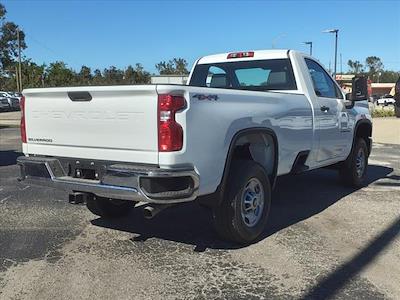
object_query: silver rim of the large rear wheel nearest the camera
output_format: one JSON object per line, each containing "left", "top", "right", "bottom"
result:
{"left": 241, "top": 178, "right": 265, "bottom": 227}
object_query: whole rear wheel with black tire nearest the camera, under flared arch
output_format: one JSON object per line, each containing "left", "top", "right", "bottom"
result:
{"left": 213, "top": 160, "right": 271, "bottom": 244}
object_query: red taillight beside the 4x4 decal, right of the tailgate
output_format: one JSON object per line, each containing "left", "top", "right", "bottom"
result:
{"left": 158, "top": 94, "right": 186, "bottom": 152}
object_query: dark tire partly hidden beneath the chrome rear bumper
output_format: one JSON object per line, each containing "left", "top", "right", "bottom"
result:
{"left": 86, "top": 196, "right": 135, "bottom": 218}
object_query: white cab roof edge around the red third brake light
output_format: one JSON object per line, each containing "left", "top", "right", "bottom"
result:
{"left": 197, "top": 49, "right": 293, "bottom": 64}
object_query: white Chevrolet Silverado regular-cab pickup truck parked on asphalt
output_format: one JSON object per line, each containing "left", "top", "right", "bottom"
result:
{"left": 18, "top": 50, "right": 372, "bottom": 243}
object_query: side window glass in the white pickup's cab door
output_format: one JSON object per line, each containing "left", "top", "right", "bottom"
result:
{"left": 305, "top": 58, "right": 343, "bottom": 99}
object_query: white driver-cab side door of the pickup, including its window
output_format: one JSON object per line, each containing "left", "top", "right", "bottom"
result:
{"left": 305, "top": 58, "right": 351, "bottom": 162}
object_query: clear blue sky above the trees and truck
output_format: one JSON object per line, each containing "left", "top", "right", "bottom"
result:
{"left": 0, "top": 0, "right": 400, "bottom": 73}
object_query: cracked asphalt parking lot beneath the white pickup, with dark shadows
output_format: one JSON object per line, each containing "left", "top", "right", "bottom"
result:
{"left": 0, "top": 127, "right": 400, "bottom": 299}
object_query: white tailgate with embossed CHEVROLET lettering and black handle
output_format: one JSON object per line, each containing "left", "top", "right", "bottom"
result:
{"left": 24, "top": 85, "right": 158, "bottom": 164}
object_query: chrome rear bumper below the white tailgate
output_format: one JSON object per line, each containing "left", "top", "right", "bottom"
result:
{"left": 17, "top": 156, "right": 199, "bottom": 203}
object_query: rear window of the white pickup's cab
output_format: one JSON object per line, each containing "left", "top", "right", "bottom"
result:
{"left": 189, "top": 59, "right": 297, "bottom": 91}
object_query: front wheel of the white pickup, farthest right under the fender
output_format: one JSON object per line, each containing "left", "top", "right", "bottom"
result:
{"left": 339, "top": 138, "right": 368, "bottom": 188}
